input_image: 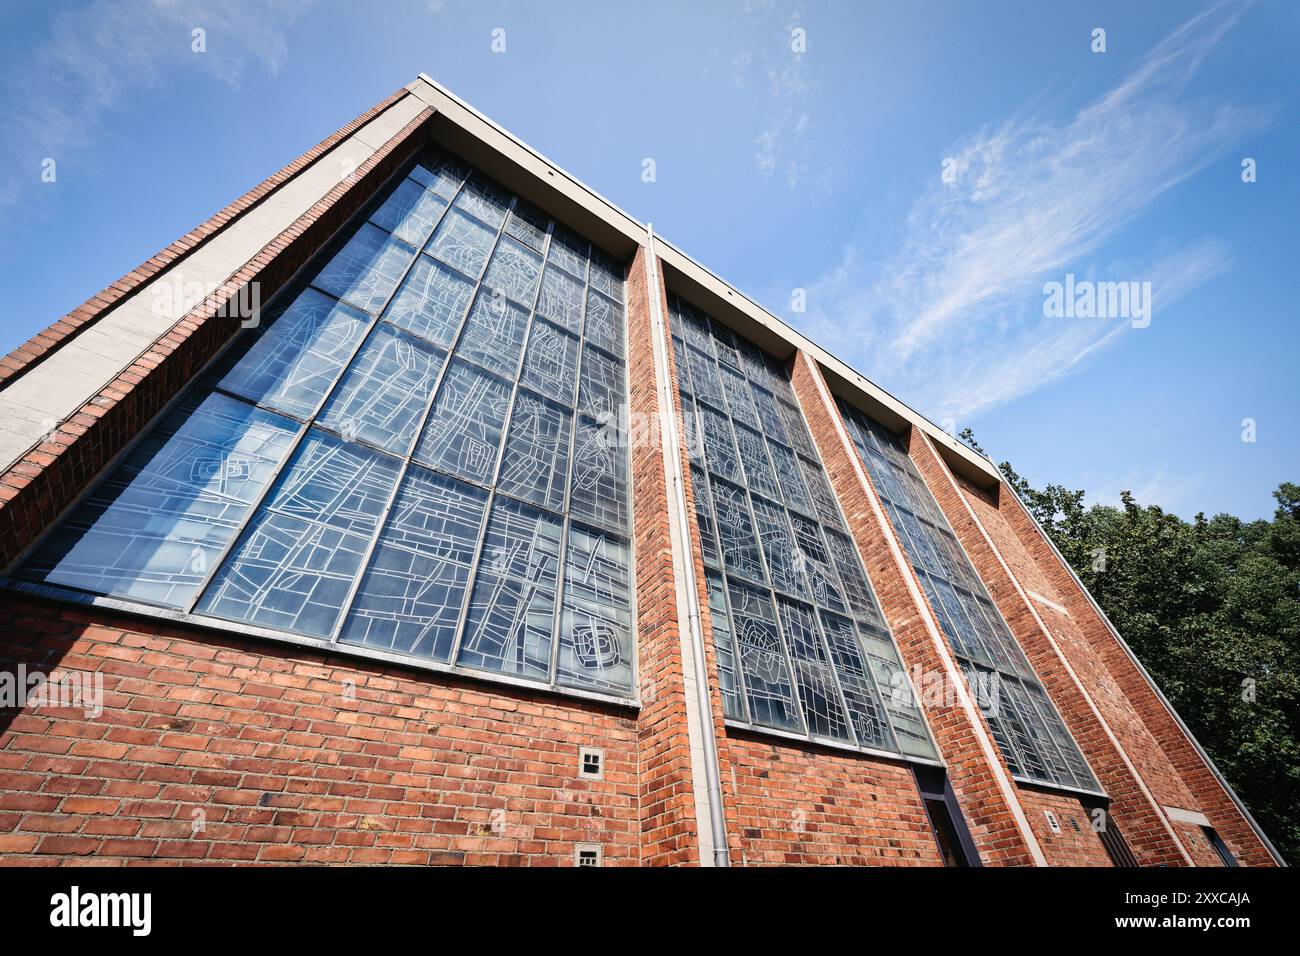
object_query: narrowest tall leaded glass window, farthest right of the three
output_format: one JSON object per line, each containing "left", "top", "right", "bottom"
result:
{"left": 840, "top": 401, "right": 1099, "bottom": 791}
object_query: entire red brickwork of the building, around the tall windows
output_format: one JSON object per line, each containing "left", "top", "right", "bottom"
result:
{"left": 0, "top": 76, "right": 1271, "bottom": 866}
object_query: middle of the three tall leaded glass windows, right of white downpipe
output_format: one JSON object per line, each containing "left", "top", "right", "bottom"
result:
{"left": 668, "top": 297, "right": 936, "bottom": 760}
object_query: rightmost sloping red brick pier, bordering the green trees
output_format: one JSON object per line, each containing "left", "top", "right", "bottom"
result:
{"left": 982, "top": 481, "right": 1277, "bottom": 866}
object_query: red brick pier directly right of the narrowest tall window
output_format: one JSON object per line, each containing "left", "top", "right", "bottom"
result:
{"left": 909, "top": 428, "right": 1190, "bottom": 866}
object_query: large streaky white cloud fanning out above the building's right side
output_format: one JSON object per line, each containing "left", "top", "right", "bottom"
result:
{"left": 802, "top": 4, "right": 1268, "bottom": 419}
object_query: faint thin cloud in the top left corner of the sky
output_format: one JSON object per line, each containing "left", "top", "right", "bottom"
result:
{"left": 0, "top": 0, "right": 311, "bottom": 204}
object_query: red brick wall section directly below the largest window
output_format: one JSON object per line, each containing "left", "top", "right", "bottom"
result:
{"left": 0, "top": 594, "right": 640, "bottom": 865}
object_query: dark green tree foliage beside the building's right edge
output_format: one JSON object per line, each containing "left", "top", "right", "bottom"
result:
{"left": 982, "top": 444, "right": 1300, "bottom": 861}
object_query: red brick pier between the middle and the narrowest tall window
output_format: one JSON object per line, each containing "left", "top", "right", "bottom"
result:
{"left": 793, "top": 352, "right": 1034, "bottom": 865}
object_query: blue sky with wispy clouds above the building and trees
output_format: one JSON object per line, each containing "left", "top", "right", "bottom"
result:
{"left": 0, "top": 0, "right": 1300, "bottom": 518}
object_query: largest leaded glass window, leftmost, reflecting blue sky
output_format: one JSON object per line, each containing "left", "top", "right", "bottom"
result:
{"left": 20, "top": 151, "right": 636, "bottom": 697}
